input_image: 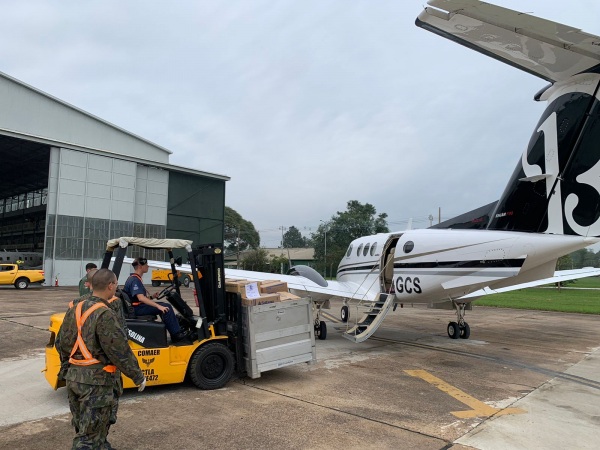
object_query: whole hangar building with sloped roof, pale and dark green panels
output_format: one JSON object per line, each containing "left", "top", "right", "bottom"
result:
{"left": 0, "top": 72, "right": 229, "bottom": 285}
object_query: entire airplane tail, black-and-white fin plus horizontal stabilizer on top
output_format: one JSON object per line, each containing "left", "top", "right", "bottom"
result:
{"left": 417, "top": 0, "right": 600, "bottom": 237}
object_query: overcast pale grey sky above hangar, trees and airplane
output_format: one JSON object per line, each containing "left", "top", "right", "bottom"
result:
{"left": 0, "top": 0, "right": 600, "bottom": 247}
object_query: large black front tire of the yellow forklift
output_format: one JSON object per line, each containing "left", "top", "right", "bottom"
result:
{"left": 189, "top": 342, "right": 235, "bottom": 390}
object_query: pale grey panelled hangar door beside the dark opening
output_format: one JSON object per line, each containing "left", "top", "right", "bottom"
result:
{"left": 44, "top": 148, "right": 169, "bottom": 285}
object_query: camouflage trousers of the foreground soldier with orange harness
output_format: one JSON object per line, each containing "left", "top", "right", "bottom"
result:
{"left": 67, "top": 380, "right": 116, "bottom": 450}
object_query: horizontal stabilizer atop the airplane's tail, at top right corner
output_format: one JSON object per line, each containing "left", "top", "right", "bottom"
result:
{"left": 416, "top": 0, "right": 600, "bottom": 82}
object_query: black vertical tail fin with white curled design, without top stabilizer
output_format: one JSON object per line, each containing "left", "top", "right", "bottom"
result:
{"left": 488, "top": 73, "right": 600, "bottom": 236}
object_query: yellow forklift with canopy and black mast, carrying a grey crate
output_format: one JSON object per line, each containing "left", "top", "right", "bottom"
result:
{"left": 45, "top": 237, "right": 244, "bottom": 389}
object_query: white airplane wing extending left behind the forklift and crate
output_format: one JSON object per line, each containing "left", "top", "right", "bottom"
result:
{"left": 123, "top": 258, "right": 376, "bottom": 302}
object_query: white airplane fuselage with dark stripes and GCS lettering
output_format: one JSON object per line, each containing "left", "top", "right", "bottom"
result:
{"left": 337, "top": 229, "right": 600, "bottom": 303}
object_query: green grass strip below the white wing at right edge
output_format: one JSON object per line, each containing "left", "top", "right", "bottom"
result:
{"left": 473, "top": 284, "right": 600, "bottom": 314}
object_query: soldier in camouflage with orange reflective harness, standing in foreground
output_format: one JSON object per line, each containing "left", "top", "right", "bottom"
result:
{"left": 55, "top": 269, "right": 146, "bottom": 449}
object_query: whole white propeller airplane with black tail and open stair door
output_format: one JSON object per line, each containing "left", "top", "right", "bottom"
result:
{"left": 134, "top": 0, "right": 600, "bottom": 342}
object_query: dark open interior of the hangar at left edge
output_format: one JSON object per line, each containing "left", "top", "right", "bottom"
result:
{"left": 0, "top": 135, "right": 50, "bottom": 252}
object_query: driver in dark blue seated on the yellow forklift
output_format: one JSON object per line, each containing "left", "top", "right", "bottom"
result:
{"left": 123, "top": 258, "right": 187, "bottom": 342}
